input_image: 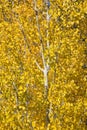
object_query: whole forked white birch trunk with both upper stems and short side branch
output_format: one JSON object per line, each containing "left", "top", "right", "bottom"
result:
{"left": 34, "top": 0, "right": 51, "bottom": 127}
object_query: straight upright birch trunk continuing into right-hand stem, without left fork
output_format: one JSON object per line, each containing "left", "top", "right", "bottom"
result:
{"left": 44, "top": 0, "right": 52, "bottom": 127}
